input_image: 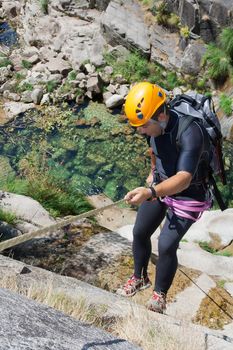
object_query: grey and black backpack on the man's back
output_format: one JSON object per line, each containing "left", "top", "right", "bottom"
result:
{"left": 169, "top": 92, "right": 227, "bottom": 210}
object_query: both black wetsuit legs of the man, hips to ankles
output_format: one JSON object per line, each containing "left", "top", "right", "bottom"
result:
{"left": 133, "top": 200, "right": 193, "bottom": 293}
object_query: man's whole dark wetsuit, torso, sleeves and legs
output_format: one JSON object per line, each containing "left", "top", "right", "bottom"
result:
{"left": 133, "top": 111, "right": 209, "bottom": 293}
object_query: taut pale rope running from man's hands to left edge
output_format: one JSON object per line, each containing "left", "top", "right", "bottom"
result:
{"left": 0, "top": 199, "right": 125, "bottom": 252}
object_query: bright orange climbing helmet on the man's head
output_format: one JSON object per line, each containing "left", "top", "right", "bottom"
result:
{"left": 125, "top": 82, "right": 166, "bottom": 127}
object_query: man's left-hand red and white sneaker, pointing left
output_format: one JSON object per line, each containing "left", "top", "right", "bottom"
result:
{"left": 116, "top": 275, "right": 151, "bottom": 297}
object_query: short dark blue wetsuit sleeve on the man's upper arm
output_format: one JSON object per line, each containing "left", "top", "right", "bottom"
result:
{"left": 176, "top": 122, "right": 204, "bottom": 176}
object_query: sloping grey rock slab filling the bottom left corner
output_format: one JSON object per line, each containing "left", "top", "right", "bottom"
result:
{"left": 0, "top": 289, "right": 140, "bottom": 350}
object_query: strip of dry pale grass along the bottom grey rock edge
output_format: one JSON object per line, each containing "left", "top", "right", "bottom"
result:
{"left": 0, "top": 276, "right": 203, "bottom": 350}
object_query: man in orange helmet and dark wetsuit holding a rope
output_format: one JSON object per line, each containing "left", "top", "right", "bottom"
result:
{"left": 117, "top": 82, "right": 212, "bottom": 313}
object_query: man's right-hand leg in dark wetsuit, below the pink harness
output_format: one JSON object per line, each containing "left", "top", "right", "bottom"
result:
{"left": 154, "top": 210, "right": 194, "bottom": 294}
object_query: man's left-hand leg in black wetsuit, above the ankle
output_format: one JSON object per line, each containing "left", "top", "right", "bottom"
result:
{"left": 133, "top": 200, "right": 166, "bottom": 278}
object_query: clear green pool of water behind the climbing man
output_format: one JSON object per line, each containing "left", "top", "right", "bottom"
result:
{"left": 0, "top": 103, "right": 149, "bottom": 200}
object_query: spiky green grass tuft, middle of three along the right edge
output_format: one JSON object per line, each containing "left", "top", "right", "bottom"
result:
{"left": 203, "top": 44, "right": 232, "bottom": 83}
